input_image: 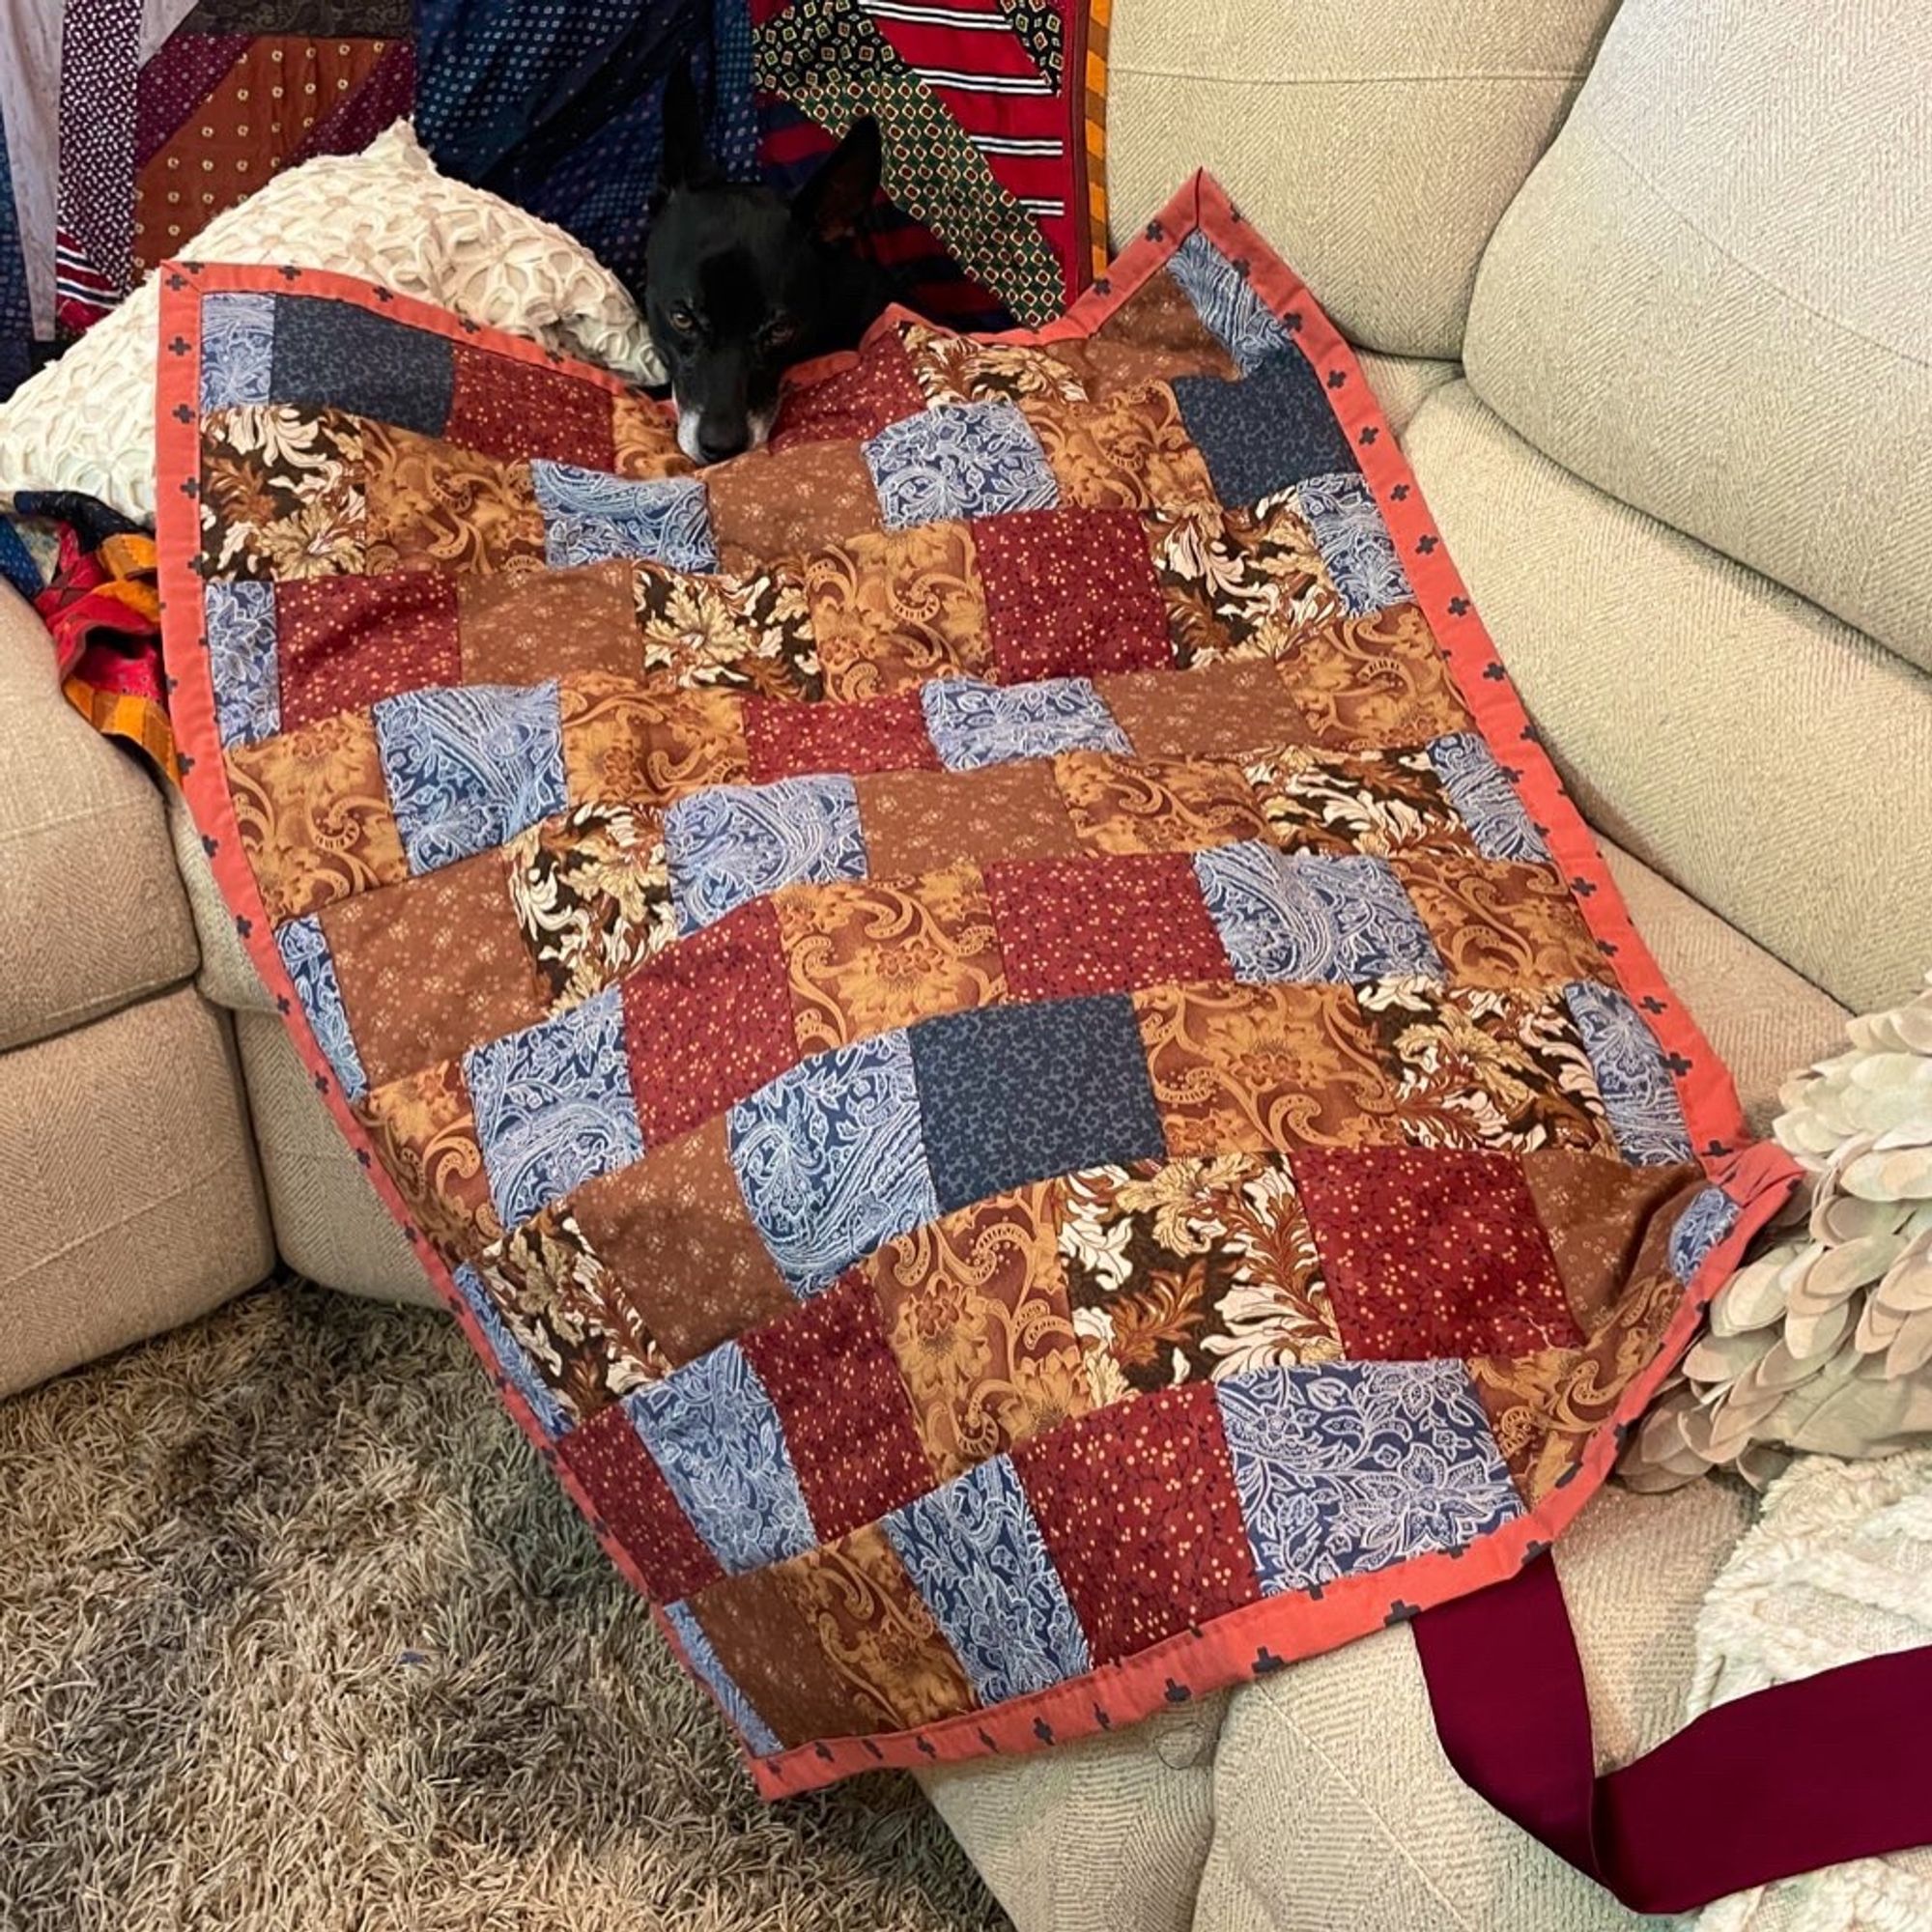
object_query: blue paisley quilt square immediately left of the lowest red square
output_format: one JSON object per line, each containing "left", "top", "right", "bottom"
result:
{"left": 881, "top": 1455, "right": 1092, "bottom": 1704}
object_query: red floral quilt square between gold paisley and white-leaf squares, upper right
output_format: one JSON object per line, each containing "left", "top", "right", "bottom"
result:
{"left": 972, "top": 510, "right": 1173, "bottom": 684}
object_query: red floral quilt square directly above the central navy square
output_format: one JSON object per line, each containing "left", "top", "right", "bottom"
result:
{"left": 985, "top": 852, "right": 1233, "bottom": 999}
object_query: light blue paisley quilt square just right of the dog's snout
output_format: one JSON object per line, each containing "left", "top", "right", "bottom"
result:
{"left": 860, "top": 402, "right": 1061, "bottom": 529}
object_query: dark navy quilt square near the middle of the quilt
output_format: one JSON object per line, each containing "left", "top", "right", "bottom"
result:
{"left": 912, "top": 993, "right": 1167, "bottom": 1213}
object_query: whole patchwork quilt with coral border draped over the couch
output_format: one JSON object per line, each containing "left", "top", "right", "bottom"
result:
{"left": 158, "top": 178, "right": 1791, "bottom": 1795}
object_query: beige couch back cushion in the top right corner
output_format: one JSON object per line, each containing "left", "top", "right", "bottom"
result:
{"left": 1466, "top": 0, "right": 1932, "bottom": 668}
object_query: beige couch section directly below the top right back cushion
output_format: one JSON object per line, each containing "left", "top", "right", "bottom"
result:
{"left": 1403, "top": 383, "right": 1932, "bottom": 1010}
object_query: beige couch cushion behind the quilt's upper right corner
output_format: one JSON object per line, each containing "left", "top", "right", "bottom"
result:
{"left": 1107, "top": 0, "right": 1613, "bottom": 355}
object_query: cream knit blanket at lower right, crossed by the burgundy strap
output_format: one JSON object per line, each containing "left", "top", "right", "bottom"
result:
{"left": 1689, "top": 1451, "right": 1932, "bottom": 1932}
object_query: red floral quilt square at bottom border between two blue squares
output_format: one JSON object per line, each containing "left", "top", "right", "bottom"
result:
{"left": 1012, "top": 1381, "right": 1262, "bottom": 1663}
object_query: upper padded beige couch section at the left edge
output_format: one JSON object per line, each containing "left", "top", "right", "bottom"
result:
{"left": 0, "top": 583, "right": 195, "bottom": 1047}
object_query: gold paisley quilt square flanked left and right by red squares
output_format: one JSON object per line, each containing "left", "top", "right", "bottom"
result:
{"left": 773, "top": 864, "right": 1009, "bottom": 1053}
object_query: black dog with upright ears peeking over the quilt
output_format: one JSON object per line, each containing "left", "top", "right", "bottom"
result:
{"left": 643, "top": 70, "right": 895, "bottom": 464}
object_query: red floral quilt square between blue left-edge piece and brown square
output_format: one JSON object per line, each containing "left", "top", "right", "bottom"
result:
{"left": 274, "top": 572, "right": 464, "bottom": 730}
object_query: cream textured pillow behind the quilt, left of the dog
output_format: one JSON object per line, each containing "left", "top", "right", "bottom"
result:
{"left": 0, "top": 122, "right": 663, "bottom": 522}
